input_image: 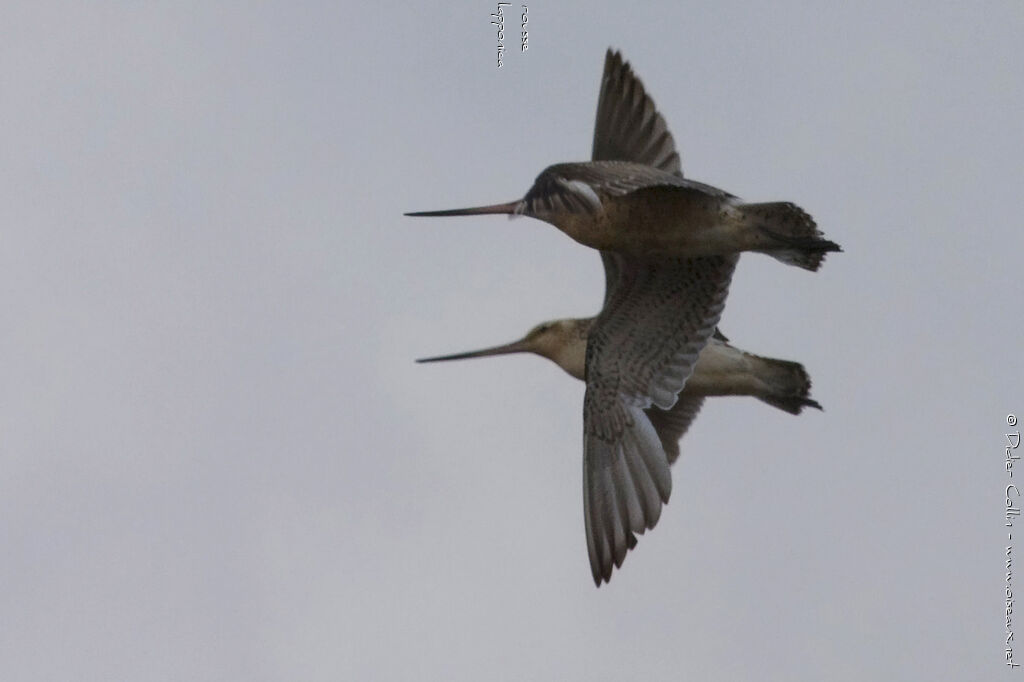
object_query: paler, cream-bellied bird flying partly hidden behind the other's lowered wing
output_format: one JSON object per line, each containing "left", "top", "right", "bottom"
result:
{"left": 416, "top": 317, "right": 822, "bottom": 465}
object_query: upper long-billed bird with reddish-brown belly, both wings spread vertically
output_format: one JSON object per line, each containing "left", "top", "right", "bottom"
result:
{"left": 408, "top": 49, "right": 839, "bottom": 587}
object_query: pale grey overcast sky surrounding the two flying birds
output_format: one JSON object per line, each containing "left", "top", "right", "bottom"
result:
{"left": 0, "top": 0, "right": 1024, "bottom": 681}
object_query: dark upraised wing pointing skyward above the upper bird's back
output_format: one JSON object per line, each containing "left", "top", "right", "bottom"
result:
{"left": 591, "top": 49, "right": 683, "bottom": 177}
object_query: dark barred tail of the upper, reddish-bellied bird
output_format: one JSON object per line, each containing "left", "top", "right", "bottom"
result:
{"left": 738, "top": 202, "right": 843, "bottom": 271}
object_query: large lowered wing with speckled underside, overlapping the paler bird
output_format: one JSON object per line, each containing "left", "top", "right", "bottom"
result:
{"left": 584, "top": 253, "right": 737, "bottom": 585}
